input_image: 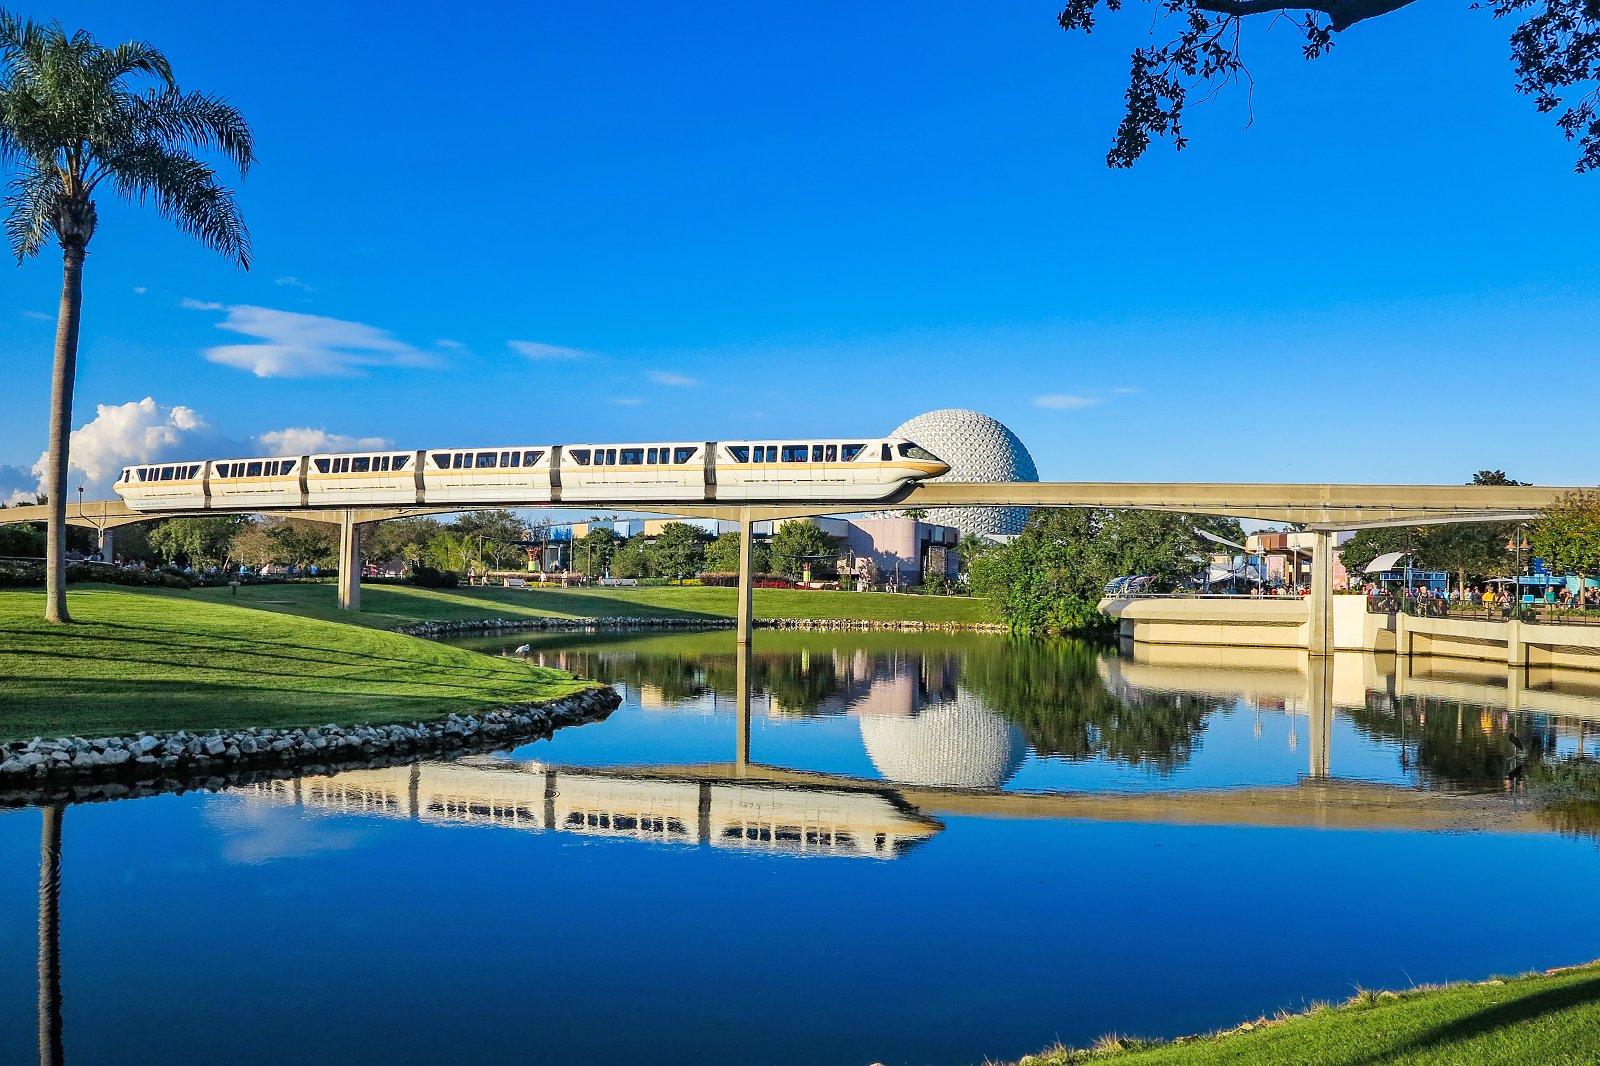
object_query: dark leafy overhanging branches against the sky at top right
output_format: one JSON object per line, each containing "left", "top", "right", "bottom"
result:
{"left": 1056, "top": 0, "right": 1600, "bottom": 171}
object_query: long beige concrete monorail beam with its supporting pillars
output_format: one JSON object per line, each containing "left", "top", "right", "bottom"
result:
{"left": 3, "top": 482, "right": 1573, "bottom": 655}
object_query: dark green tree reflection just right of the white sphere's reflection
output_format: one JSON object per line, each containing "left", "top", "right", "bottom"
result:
{"left": 962, "top": 637, "right": 1229, "bottom": 773}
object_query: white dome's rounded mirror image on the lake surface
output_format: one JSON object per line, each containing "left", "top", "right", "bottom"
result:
{"left": 861, "top": 690, "right": 1027, "bottom": 789}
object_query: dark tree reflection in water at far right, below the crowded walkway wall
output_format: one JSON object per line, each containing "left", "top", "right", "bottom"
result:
{"left": 1349, "top": 691, "right": 1523, "bottom": 787}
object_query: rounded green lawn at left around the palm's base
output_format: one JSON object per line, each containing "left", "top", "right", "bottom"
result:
{"left": 0, "top": 586, "right": 582, "bottom": 739}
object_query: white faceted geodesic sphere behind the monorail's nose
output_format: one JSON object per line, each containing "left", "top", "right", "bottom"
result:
{"left": 890, "top": 407, "right": 1038, "bottom": 535}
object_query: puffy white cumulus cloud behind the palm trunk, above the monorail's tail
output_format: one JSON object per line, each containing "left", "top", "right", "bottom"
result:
{"left": 34, "top": 397, "right": 222, "bottom": 499}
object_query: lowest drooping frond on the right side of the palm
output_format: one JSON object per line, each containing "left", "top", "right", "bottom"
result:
{"left": 107, "top": 139, "right": 250, "bottom": 271}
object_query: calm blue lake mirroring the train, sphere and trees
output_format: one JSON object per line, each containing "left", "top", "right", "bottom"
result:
{"left": 0, "top": 632, "right": 1600, "bottom": 1066}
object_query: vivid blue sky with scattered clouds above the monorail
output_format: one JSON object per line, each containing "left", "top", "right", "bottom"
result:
{"left": 0, "top": 3, "right": 1600, "bottom": 498}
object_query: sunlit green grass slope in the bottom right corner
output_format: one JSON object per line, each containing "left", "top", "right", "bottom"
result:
{"left": 1019, "top": 964, "right": 1600, "bottom": 1066}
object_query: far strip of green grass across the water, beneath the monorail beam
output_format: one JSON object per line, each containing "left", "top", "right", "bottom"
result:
{"left": 174, "top": 584, "right": 994, "bottom": 629}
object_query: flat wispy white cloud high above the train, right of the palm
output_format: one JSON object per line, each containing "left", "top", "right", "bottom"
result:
{"left": 184, "top": 301, "right": 434, "bottom": 378}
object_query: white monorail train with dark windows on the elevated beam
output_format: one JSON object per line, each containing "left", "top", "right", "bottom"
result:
{"left": 117, "top": 437, "right": 950, "bottom": 511}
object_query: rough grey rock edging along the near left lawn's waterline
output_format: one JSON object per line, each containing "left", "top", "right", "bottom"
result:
{"left": 0, "top": 687, "right": 622, "bottom": 807}
